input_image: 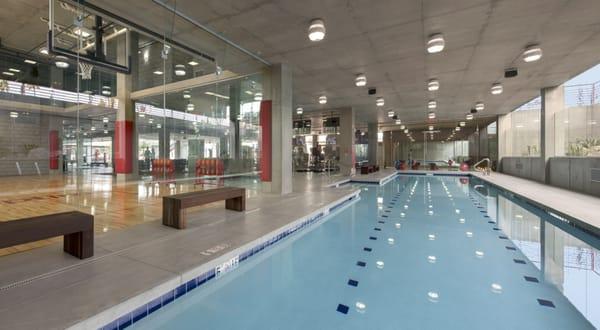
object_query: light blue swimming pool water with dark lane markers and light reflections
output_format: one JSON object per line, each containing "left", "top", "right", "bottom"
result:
{"left": 133, "top": 176, "right": 600, "bottom": 329}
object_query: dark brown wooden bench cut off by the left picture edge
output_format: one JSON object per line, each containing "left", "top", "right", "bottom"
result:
{"left": 0, "top": 211, "right": 94, "bottom": 259}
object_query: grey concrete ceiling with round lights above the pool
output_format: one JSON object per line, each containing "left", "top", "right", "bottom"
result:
{"left": 2, "top": 0, "right": 600, "bottom": 129}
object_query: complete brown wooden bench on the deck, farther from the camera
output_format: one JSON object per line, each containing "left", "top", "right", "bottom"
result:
{"left": 163, "top": 187, "right": 246, "bottom": 229}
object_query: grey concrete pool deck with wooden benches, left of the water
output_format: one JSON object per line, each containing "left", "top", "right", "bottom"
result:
{"left": 0, "top": 186, "right": 359, "bottom": 329}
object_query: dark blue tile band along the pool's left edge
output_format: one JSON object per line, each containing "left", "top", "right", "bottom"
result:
{"left": 100, "top": 194, "right": 359, "bottom": 330}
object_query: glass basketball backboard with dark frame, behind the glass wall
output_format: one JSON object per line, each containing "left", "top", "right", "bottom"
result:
{"left": 48, "top": 0, "right": 131, "bottom": 74}
